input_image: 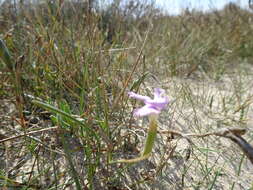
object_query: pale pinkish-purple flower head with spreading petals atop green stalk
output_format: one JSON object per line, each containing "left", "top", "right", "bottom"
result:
{"left": 128, "top": 88, "right": 169, "bottom": 117}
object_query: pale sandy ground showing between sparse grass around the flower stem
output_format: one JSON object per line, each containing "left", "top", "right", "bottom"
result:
{"left": 0, "top": 64, "right": 253, "bottom": 190}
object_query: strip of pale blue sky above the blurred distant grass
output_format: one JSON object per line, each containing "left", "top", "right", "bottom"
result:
{"left": 154, "top": 0, "right": 248, "bottom": 14}
